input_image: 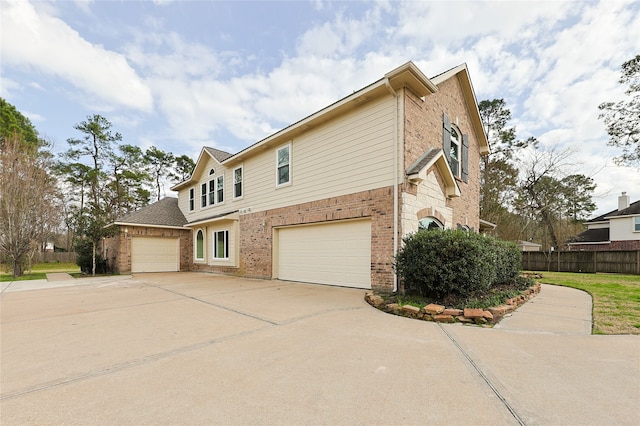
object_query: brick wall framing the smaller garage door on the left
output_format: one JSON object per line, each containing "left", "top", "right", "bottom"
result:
{"left": 105, "top": 225, "right": 193, "bottom": 274}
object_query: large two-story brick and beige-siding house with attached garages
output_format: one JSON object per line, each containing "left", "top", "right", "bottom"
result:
{"left": 108, "top": 62, "right": 489, "bottom": 291}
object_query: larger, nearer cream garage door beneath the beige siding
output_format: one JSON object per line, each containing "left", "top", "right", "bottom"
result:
{"left": 277, "top": 220, "right": 371, "bottom": 288}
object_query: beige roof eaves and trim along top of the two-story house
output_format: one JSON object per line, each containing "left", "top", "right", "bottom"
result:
{"left": 171, "top": 61, "right": 489, "bottom": 191}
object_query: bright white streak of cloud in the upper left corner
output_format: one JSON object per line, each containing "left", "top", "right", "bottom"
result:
{"left": 1, "top": 0, "right": 153, "bottom": 111}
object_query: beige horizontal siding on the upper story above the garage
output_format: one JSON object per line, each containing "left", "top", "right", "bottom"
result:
{"left": 179, "top": 96, "right": 395, "bottom": 222}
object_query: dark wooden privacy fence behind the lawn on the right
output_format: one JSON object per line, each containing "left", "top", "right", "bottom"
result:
{"left": 522, "top": 250, "right": 640, "bottom": 275}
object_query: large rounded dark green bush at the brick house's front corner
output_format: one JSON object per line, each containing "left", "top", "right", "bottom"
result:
{"left": 394, "top": 230, "right": 522, "bottom": 299}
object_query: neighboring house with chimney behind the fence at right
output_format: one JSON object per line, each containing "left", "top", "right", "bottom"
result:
{"left": 567, "top": 192, "right": 640, "bottom": 251}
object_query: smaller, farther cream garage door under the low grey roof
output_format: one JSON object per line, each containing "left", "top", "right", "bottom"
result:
{"left": 131, "top": 237, "right": 180, "bottom": 272}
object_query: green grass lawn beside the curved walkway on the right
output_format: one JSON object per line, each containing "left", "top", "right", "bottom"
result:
{"left": 537, "top": 272, "right": 640, "bottom": 334}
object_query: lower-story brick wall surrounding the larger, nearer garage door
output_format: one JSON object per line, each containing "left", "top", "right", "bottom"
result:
{"left": 191, "top": 186, "right": 394, "bottom": 291}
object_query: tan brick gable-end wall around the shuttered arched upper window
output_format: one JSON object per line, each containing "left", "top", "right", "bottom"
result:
{"left": 402, "top": 78, "right": 480, "bottom": 235}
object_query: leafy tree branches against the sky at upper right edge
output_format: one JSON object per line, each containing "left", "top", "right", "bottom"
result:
{"left": 598, "top": 55, "right": 640, "bottom": 167}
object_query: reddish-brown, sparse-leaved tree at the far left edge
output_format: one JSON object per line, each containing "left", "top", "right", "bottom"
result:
{"left": 0, "top": 132, "right": 61, "bottom": 277}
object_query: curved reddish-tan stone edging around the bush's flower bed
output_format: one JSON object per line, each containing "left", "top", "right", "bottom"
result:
{"left": 365, "top": 283, "right": 540, "bottom": 325}
